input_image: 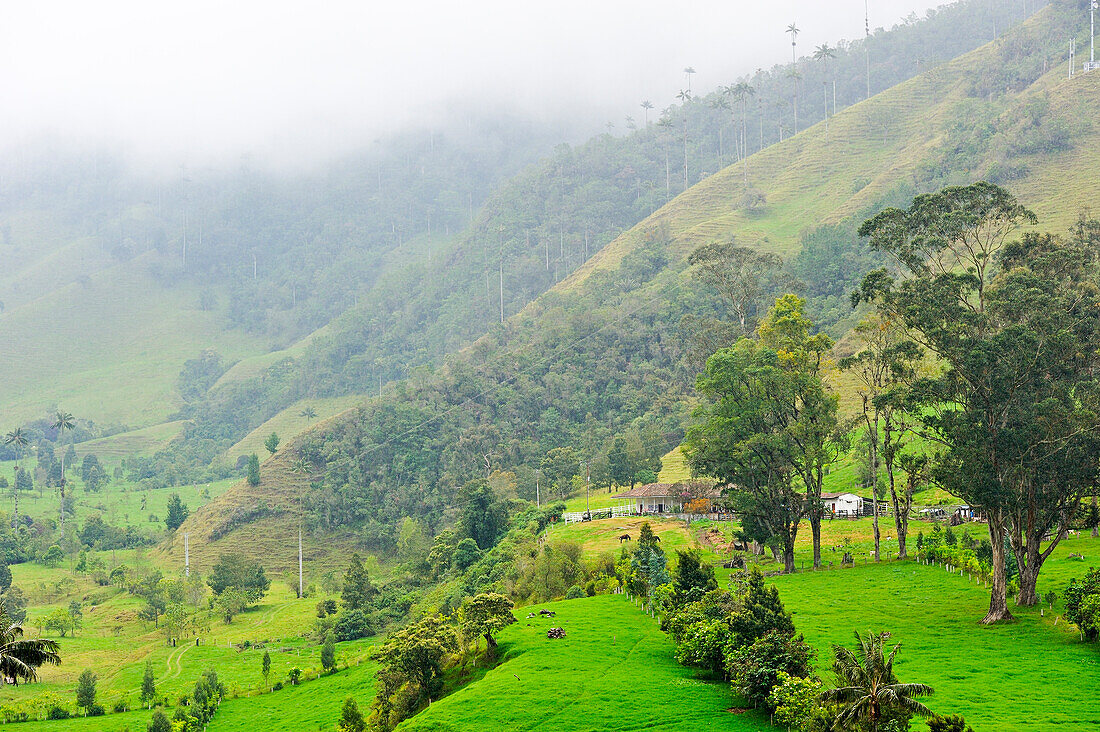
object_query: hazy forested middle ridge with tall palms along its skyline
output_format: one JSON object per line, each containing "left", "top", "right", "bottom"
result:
{"left": 152, "top": 0, "right": 1047, "bottom": 472}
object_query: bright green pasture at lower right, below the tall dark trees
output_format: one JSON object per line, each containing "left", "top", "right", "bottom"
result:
{"left": 774, "top": 550, "right": 1100, "bottom": 732}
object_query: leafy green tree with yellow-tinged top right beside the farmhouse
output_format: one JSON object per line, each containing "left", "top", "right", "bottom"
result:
{"left": 685, "top": 295, "right": 842, "bottom": 571}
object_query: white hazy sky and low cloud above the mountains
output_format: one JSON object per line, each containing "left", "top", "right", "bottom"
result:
{"left": 0, "top": 0, "right": 944, "bottom": 167}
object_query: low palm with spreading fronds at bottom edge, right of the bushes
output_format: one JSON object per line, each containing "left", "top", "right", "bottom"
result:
{"left": 822, "top": 632, "right": 933, "bottom": 732}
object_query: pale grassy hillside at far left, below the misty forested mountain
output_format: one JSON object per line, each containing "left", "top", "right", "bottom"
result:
{"left": 0, "top": 253, "right": 265, "bottom": 429}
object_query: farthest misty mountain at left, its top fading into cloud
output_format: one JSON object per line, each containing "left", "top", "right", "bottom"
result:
{"left": 0, "top": 114, "right": 558, "bottom": 429}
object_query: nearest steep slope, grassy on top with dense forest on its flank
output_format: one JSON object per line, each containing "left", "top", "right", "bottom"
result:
{"left": 165, "top": 1, "right": 1100, "bottom": 556}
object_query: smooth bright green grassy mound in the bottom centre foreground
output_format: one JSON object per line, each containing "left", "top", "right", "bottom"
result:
{"left": 398, "top": 596, "right": 770, "bottom": 732}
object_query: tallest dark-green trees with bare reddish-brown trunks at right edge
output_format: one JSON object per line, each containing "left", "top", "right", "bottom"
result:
{"left": 859, "top": 183, "right": 1100, "bottom": 622}
